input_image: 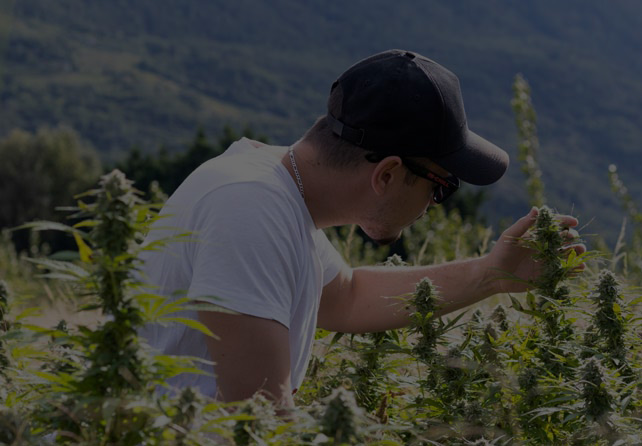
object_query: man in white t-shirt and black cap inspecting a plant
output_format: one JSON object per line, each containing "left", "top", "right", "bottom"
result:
{"left": 138, "top": 50, "right": 585, "bottom": 406}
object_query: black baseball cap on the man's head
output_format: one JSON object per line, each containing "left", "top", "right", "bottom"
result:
{"left": 327, "top": 50, "right": 508, "bottom": 185}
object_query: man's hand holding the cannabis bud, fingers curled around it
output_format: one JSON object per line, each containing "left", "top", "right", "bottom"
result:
{"left": 482, "top": 208, "right": 586, "bottom": 293}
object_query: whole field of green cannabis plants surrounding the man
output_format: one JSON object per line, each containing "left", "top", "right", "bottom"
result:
{"left": 0, "top": 78, "right": 642, "bottom": 446}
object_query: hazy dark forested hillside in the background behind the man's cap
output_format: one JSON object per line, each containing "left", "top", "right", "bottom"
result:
{"left": 0, "top": 0, "right": 642, "bottom": 242}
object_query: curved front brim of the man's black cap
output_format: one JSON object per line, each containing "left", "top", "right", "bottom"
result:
{"left": 433, "top": 130, "right": 509, "bottom": 186}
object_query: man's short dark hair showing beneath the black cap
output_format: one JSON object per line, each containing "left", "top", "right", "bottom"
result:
{"left": 302, "top": 85, "right": 417, "bottom": 185}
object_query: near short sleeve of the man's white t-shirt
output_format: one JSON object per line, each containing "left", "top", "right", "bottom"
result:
{"left": 188, "top": 184, "right": 300, "bottom": 328}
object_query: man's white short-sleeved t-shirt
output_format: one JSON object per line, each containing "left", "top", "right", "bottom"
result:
{"left": 140, "top": 138, "right": 345, "bottom": 396}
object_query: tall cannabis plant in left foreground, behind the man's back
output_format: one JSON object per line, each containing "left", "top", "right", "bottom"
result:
{"left": 15, "top": 171, "right": 161, "bottom": 444}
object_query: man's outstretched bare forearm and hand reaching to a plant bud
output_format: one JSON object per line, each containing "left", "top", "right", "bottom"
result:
{"left": 317, "top": 211, "right": 586, "bottom": 333}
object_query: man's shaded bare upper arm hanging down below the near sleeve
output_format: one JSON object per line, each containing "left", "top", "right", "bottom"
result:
{"left": 198, "top": 311, "right": 294, "bottom": 407}
